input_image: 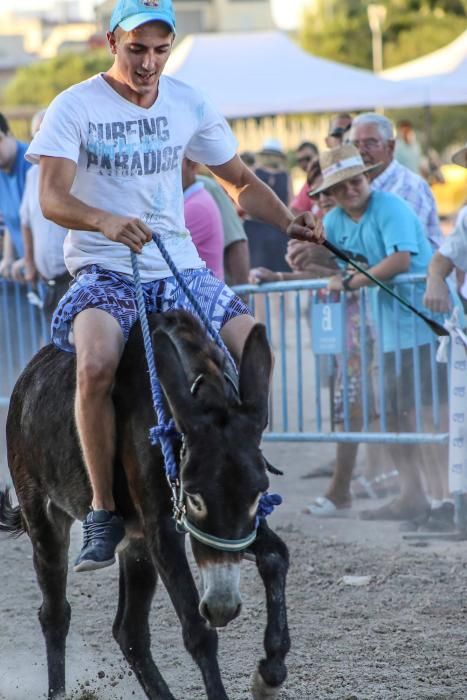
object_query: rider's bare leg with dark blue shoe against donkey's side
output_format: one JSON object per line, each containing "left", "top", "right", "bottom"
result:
{"left": 73, "top": 309, "right": 124, "bottom": 571}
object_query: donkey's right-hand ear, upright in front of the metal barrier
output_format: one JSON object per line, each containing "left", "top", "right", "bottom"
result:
{"left": 239, "top": 323, "right": 272, "bottom": 431}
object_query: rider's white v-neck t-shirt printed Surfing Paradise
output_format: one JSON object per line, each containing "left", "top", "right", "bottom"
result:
{"left": 26, "top": 75, "right": 237, "bottom": 282}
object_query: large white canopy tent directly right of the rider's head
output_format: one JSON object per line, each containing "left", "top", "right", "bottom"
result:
{"left": 166, "top": 32, "right": 418, "bottom": 119}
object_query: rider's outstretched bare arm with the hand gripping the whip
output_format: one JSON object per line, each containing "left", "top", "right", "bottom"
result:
{"left": 208, "top": 155, "right": 324, "bottom": 243}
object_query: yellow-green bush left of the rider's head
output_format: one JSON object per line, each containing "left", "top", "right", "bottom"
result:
{"left": 2, "top": 49, "right": 112, "bottom": 107}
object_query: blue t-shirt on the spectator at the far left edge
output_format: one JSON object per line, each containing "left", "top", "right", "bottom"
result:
{"left": 0, "top": 141, "right": 31, "bottom": 258}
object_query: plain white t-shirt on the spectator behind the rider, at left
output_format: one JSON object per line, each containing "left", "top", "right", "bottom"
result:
{"left": 19, "top": 165, "right": 67, "bottom": 280}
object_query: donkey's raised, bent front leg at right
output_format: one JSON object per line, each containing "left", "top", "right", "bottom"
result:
{"left": 249, "top": 520, "right": 290, "bottom": 700}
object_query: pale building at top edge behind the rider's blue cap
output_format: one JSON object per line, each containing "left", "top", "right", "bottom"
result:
{"left": 96, "top": 0, "right": 275, "bottom": 38}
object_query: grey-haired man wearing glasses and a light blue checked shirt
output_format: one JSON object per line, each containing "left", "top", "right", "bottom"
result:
{"left": 350, "top": 112, "right": 442, "bottom": 250}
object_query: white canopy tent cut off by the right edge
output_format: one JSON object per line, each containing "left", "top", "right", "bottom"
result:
{"left": 382, "top": 31, "right": 467, "bottom": 107}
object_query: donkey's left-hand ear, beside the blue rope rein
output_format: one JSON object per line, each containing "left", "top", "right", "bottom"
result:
{"left": 152, "top": 328, "right": 196, "bottom": 433}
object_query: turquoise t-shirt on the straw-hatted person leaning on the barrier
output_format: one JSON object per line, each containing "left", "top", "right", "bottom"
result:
{"left": 324, "top": 192, "right": 432, "bottom": 352}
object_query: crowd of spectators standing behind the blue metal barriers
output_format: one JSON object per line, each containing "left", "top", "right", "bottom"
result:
{"left": 0, "top": 106, "right": 467, "bottom": 530}
